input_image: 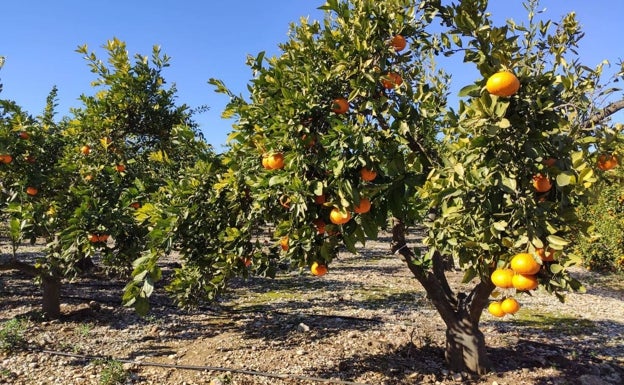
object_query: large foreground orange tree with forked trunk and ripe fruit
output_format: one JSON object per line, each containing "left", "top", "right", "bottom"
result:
{"left": 126, "top": 0, "right": 624, "bottom": 373}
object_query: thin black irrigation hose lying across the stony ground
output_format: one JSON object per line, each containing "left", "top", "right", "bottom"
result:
{"left": 39, "top": 349, "right": 367, "bottom": 385}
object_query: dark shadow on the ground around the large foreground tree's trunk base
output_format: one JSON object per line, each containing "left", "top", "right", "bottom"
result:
{"left": 314, "top": 322, "right": 624, "bottom": 385}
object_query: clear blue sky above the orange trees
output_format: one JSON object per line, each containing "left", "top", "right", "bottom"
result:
{"left": 0, "top": 0, "right": 624, "bottom": 150}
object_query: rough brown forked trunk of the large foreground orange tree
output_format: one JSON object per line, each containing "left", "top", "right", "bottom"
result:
{"left": 392, "top": 218, "right": 494, "bottom": 374}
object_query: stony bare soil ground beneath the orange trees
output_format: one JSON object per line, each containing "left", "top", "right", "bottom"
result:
{"left": 0, "top": 234, "right": 624, "bottom": 385}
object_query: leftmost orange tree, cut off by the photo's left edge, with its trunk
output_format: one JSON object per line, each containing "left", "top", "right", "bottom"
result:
{"left": 0, "top": 85, "right": 67, "bottom": 316}
